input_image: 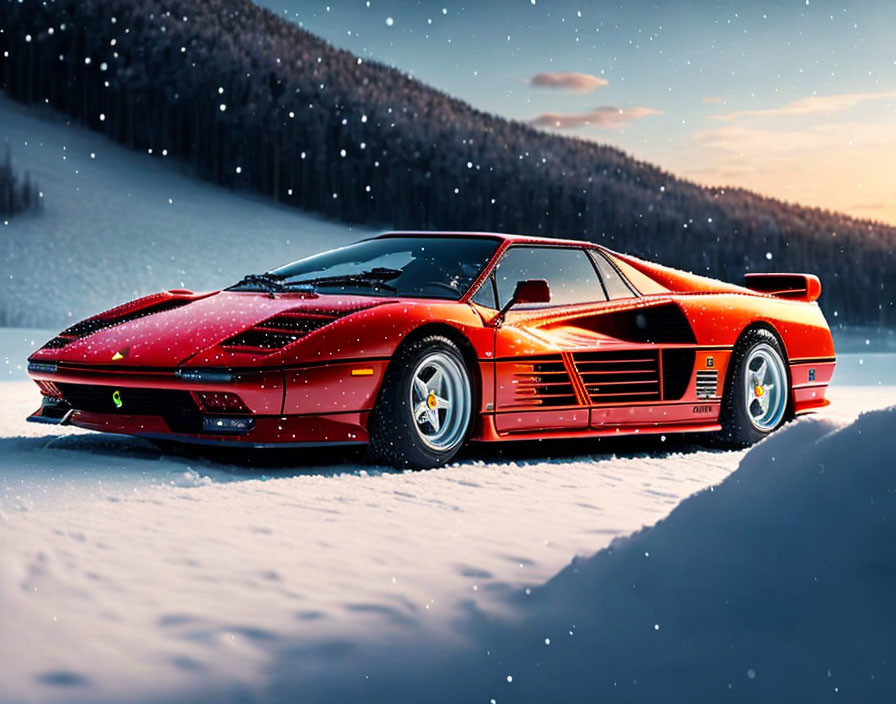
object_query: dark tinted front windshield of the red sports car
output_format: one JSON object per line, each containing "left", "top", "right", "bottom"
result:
{"left": 230, "top": 236, "right": 499, "bottom": 300}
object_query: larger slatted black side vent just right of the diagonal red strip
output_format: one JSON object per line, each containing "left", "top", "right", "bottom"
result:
{"left": 573, "top": 350, "right": 660, "bottom": 404}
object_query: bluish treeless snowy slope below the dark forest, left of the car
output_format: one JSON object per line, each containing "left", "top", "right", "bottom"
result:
{"left": 0, "top": 96, "right": 370, "bottom": 328}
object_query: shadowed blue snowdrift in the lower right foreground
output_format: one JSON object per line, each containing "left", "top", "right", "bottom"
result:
{"left": 274, "top": 407, "right": 896, "bottom": 704}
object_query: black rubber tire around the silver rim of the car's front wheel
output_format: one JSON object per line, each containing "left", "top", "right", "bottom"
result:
{"left": 366, "top": 335, "right": 476, "bottom": 469}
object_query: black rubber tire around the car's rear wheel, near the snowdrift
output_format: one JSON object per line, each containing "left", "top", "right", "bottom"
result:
{"left": 716, "top": 328, "right": 790, "bottom": 447}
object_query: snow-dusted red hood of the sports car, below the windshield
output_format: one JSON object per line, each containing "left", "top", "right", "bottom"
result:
{"left": 30, "top": 291, "right": 392, "bottom": 368}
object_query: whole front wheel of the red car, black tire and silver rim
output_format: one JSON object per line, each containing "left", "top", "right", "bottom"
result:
{"left": 367, "top": 335, "right": 473, "bottom": 469}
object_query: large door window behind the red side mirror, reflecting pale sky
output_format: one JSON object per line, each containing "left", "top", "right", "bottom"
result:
{"left": 495, "top": 247, "right": 607, "bottom": 306}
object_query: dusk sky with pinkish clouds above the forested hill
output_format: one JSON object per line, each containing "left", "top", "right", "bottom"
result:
{"left": 252, "top": 0, "right": 896, "bottom": 223}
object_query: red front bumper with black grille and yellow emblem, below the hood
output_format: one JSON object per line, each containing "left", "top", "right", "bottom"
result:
{"left": 28, "top": 361, "right": 386, "bottom": 447}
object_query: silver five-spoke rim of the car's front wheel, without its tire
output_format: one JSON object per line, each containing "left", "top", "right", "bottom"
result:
{"left": 410, "top": 352, "right": 472, "bottom": 452}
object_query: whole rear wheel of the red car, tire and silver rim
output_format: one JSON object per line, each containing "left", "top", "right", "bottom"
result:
{"left": 720, "top": 329, "right": 790, "bottom": 447}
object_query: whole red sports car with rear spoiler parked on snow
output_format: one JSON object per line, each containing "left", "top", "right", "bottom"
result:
{"left": 28, "top": 232, "right": 835, "bottom": 468}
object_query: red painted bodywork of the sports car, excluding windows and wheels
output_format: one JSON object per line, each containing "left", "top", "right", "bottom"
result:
{"left": 29, "top": 233, "right": 835, "bottom": 446}
